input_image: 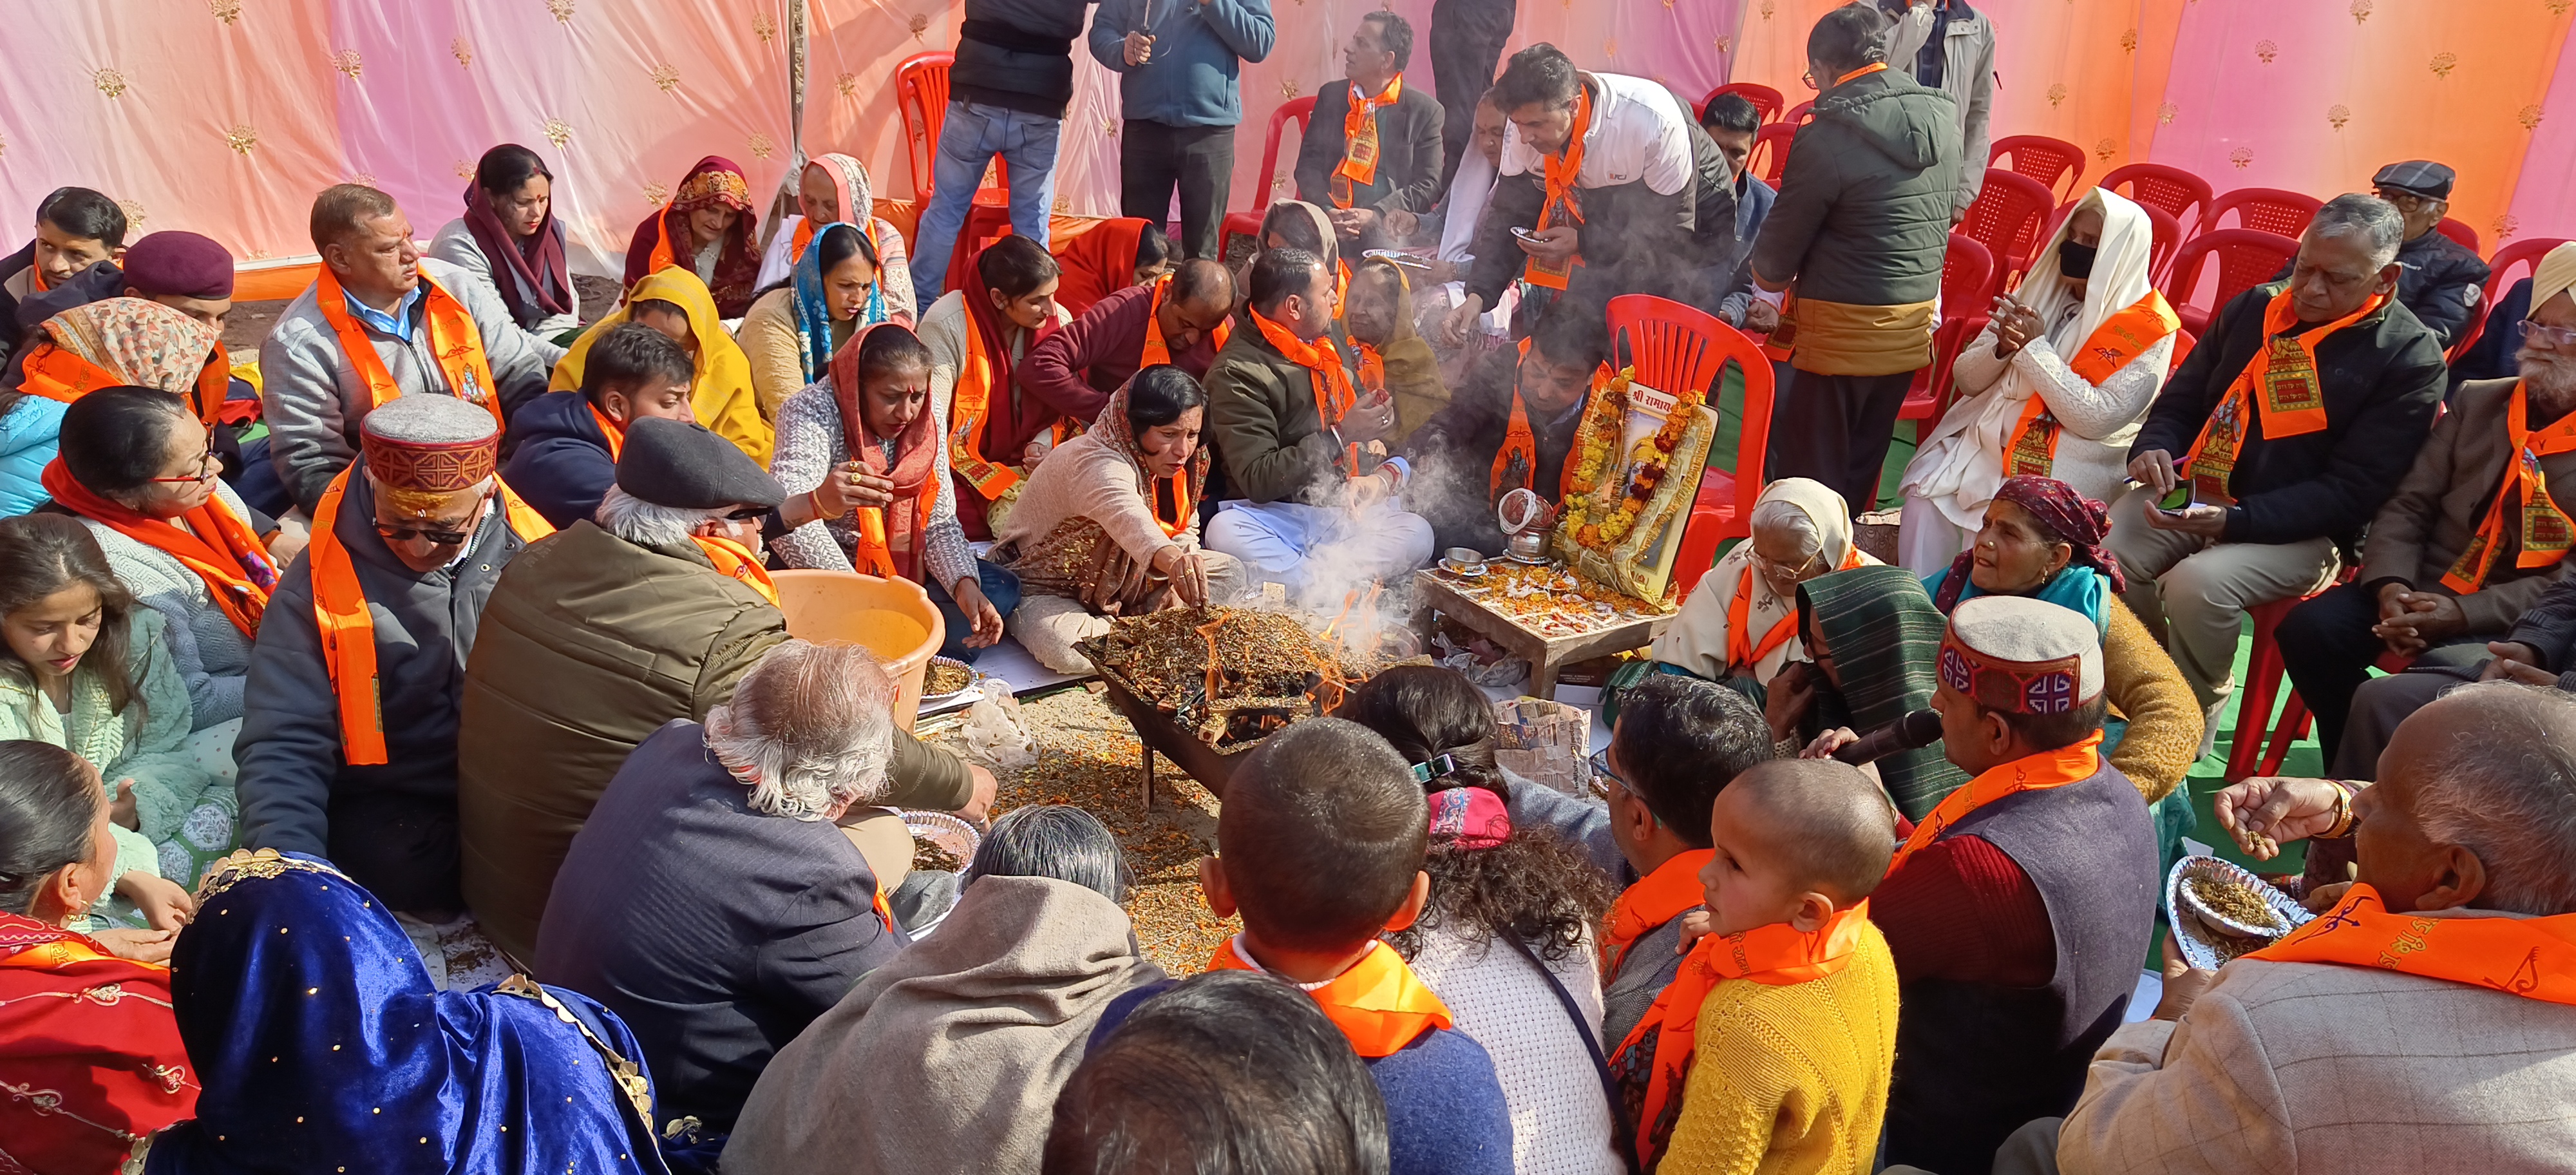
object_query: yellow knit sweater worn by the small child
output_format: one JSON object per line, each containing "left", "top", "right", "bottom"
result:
{"left": 1656, "top": 925, "right": 1896, "bottom": 1175}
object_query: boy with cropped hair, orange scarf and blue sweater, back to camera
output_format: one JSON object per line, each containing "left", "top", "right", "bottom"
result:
{"left": 1092, "top": 719, "right": 1512, "bottom": 1175}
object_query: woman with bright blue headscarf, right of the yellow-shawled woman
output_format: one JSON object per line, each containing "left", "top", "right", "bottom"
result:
{"left": 734, "top": 224, "right": 912, "bottom": 420}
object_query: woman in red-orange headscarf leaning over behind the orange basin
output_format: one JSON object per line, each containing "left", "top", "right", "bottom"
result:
{"left": 770, "top": 322, "right": 1020, "bottom": 660}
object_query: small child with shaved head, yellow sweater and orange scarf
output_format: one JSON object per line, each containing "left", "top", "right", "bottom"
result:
{"left": 1636, "top": 760, "right": 1896, "bottom": 1175}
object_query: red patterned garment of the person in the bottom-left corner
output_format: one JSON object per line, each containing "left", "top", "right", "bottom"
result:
{"left": 0, "top": 915, "right": 198, "bottom": 1170}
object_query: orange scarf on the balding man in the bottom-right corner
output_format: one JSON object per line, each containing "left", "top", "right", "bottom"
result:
{"left": 2246, "top": 884, "right": 2576, "bottom": 1005}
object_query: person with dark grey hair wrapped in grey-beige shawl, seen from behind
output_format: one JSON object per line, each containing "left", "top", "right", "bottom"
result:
{"left": 724, "top": 804, "right": 1164, "bottom": 1175}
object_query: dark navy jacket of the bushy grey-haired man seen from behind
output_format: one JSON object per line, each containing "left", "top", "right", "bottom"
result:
{"left": 536, "top": 721, "right": 904, "bottom": 1134}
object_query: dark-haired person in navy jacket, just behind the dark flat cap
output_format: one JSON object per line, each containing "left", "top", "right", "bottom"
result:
{"left": 500, "top": 322, "right": 698, "bottom": 528}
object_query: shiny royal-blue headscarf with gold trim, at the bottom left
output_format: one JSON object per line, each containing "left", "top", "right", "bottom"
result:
{"left": 147, "top": 850, "right": 690, "bottom": 1175}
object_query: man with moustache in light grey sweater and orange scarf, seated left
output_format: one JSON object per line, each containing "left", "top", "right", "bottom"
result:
{"left": 260, "top": 183, "right": 564, "bottom": 515}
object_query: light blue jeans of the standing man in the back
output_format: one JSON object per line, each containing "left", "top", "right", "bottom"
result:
{"left": 912, "top": 100, "right": 1064, "bottom": 314}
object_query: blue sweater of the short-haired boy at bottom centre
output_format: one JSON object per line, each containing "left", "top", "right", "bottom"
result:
{"left": 1084, "top": 979, "right": 1512, "bottom": 1175}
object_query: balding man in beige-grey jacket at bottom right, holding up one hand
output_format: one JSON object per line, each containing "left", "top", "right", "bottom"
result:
{"left": 2025, "top": 683, "right": 2576, "bottom": 1175}
